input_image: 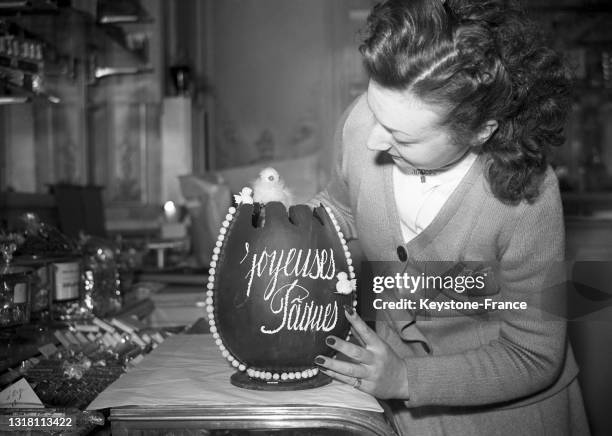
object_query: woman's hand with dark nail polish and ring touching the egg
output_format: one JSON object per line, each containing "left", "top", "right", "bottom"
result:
{"left": 315, "top": 306, "right": 409, "bottom": 399}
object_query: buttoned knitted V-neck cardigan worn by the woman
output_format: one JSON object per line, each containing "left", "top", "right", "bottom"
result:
{"left": 314, "top": 96, "right": 588, "bottom": 434}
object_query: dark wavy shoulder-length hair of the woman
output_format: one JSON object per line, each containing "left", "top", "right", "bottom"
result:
{"left": 360, "top": 0, "right": 571, "bottom": 203}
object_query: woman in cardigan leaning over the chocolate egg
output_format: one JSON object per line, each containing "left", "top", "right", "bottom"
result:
{"left": 315, "top": 0, "right": 588, "bottom": 435}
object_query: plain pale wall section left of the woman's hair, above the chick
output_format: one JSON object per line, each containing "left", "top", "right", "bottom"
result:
{"left": 206, "top": 0, "right": 371, "bottom": 174}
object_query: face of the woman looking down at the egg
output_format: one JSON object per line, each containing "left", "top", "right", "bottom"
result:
{"left": 367, "top": 80, "right": 470, "bottom": 170}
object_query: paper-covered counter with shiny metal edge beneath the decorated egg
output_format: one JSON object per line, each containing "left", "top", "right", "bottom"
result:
{"left": 88, "top": 334, "right": 396, "bottom": 436}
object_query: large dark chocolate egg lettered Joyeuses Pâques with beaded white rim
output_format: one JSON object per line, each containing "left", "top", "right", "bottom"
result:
{"left": 207, "top": 202, "right": 356, "bottom": 389}
